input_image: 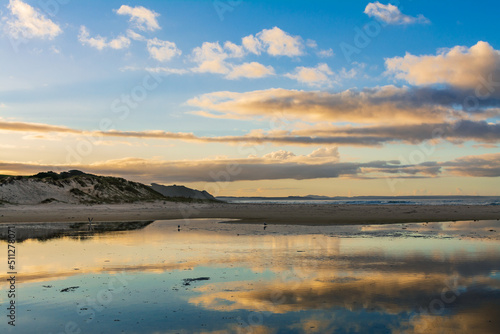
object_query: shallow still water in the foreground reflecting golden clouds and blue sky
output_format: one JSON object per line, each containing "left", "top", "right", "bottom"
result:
{"left": 0, "top": 219, "right": 500, "bottom": 333}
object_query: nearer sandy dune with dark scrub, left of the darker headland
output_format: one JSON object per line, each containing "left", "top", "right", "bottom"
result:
{"left": 0, "top": 170, "right": 166, "bottom": 204}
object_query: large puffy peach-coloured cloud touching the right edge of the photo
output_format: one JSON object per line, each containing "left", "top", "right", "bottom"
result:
{"left": 385, "top": 41, "right": 500, "bottom": 97}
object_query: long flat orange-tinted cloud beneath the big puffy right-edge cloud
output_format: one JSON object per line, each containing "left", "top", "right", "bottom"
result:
{"left": 187, "top": 86, "right": 464, "bottom": 123}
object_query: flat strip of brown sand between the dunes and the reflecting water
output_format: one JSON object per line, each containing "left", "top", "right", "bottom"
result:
{"left": 0, "top": 202, "right": 500, "bottom": 225}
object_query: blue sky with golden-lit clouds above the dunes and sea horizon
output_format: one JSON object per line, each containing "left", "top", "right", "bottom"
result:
{"left": 0, "top": 0, "right": 500, "bottom": 196}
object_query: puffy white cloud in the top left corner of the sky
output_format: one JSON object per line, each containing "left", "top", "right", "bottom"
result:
{"left": 6, "top": 0, "right": 62, "bottom": 39}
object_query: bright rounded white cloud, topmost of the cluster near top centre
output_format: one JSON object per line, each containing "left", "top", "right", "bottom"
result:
{"left": 257, "top": 27, "right": 304, "bottom": 57}
